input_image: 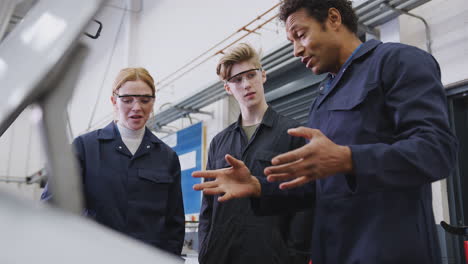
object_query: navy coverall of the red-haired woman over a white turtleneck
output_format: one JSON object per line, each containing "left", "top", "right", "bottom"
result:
{"left": 42, "top": 122, "right": 185, "bottom": 255}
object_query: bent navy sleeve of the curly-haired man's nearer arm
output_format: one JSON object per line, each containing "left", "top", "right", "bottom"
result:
{"left": 349, "top": 48, "right": 457, "bottom": 190}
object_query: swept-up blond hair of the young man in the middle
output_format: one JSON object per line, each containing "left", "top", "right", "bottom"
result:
{"left": 216, "top": 43, "right": 262, "bottom": 81}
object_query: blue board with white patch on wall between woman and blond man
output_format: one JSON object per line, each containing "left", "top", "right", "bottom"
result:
{"left": 172, "top": 122, "right": 203, "bottom": 214}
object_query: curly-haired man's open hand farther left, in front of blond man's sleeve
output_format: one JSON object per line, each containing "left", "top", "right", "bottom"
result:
{"left": 192, "top": 154, "right": 261, "bottom": 202}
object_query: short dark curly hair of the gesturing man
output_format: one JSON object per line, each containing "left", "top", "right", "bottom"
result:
{"left": 279, "top": 0, "right": 358, "bottom": 34}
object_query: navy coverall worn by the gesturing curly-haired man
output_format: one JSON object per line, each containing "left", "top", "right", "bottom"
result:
{"left": 252, "top": 40, "right": 457, "bottom": 264}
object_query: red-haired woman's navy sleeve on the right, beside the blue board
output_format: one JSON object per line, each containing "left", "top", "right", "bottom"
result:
{"left": 166, "top": 154, "right": 185, "bottom": 255}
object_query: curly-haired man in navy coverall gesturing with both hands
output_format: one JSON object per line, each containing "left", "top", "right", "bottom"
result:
{"left": 193, "top": 0, "right": 457, "bottom": 264}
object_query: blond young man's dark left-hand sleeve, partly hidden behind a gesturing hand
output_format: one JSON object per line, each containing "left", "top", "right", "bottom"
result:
{"left": 198, "top": 140, "right": 216, "bottom": 255}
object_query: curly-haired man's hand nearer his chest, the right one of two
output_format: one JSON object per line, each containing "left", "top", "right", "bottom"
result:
{"left": 264, "top": 127, "right": 352, "bottom": 189}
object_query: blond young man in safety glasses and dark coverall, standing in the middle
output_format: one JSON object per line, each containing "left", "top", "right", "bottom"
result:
{"left": 198, "top": 44, "right": 312, "bottom": 264}
